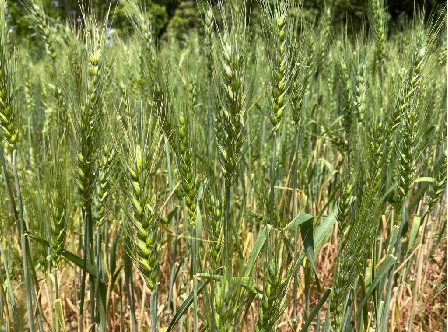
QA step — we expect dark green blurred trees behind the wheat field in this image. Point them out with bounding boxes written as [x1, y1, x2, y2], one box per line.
[7, 0, 446, 37]
